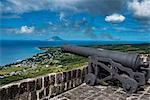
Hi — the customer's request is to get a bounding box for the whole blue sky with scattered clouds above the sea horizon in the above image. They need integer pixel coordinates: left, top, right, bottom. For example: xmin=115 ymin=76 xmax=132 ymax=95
xmin=0 ymin=0 xmax=150 ymax=42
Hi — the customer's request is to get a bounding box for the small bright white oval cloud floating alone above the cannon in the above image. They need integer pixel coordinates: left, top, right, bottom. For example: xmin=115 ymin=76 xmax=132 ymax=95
xmin=105 ymin=14 xmax=125 ymax=23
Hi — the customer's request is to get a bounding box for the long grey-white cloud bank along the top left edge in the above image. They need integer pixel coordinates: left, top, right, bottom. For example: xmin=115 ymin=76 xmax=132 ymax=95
xmin=0 ymin=0 xmax=80 ymax=13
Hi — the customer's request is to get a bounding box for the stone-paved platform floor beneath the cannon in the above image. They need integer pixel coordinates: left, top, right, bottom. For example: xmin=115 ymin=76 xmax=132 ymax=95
xmin=50 ymin=83 xmax=150 ymax=100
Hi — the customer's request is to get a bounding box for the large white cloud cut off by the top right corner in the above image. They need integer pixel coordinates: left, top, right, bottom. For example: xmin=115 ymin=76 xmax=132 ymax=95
xmin=128 ymin=0 xmax=150 ymax=18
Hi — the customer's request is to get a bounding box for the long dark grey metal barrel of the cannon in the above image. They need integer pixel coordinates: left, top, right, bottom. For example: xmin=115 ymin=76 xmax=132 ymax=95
xmin=61 ymin=45 xmax=142 ymax=70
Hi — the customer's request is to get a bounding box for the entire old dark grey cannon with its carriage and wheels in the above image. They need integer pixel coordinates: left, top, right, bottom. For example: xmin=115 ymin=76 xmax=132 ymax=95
xmin=61 ymin=45 xmax=150 ymax=93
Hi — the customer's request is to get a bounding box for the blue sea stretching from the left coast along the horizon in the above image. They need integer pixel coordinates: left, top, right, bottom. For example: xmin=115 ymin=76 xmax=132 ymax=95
xmin=0 ymin=40 xmax=149 ymax=66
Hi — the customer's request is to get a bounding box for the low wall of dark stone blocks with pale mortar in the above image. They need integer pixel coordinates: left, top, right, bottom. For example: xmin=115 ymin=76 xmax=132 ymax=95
xmin=0 ymin=67 xmax=87 ymax=100
